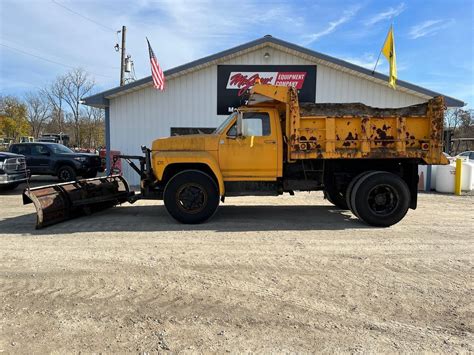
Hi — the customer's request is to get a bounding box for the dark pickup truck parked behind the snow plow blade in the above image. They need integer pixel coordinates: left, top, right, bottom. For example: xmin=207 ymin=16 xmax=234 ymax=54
xmin=10 ymin=142 xmax=104 ymax=181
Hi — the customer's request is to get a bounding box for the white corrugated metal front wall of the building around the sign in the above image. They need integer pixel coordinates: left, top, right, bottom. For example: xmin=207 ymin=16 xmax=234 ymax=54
xmin=110 ymin=47 xmax=426 ymax=185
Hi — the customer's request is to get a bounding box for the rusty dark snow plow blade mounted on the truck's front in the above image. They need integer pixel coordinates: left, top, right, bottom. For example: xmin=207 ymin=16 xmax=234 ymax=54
xmin=23 ymin=175 xmax=134 ymax=229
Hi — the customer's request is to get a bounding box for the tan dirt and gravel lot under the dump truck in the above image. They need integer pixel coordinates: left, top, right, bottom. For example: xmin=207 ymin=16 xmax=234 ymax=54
xmin=0 ymin=179 xmax=474 ymax=353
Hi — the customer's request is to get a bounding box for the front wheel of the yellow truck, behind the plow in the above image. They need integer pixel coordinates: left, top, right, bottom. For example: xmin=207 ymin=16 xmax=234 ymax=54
xmin=163 ymin=170 xmax=219 ymax=224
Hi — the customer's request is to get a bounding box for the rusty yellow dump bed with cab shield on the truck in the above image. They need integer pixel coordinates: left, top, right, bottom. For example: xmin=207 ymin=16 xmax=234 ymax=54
xmin=249 ymin=85 xmax=448 ymax=164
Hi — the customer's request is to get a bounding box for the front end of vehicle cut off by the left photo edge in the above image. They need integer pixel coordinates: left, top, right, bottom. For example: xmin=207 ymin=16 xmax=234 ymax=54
xmin=0 ymin=152 xmax=28 ymax=190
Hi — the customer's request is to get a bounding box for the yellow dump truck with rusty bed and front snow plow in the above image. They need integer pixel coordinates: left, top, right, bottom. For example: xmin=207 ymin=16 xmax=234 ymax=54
xmin=24 ymin=84 xmax=448 ymax=227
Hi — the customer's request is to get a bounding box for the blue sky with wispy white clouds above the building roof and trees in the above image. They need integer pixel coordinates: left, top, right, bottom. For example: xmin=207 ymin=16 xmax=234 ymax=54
xmin=0 ymin=0 xmax=474 ymax=108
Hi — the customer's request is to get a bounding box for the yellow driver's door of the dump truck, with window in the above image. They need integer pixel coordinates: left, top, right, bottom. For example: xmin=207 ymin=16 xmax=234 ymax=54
xmin=219 ymin=111 xmax=278 ymax=181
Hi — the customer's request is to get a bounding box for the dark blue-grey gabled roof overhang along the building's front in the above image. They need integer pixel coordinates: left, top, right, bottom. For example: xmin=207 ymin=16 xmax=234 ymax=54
xmin=83 ymin=35 xmax=465 ymax=108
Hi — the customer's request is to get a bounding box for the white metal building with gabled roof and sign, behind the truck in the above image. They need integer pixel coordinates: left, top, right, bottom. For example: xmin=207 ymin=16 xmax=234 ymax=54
xmin=84 ymin=35 xmax=464 ymax=184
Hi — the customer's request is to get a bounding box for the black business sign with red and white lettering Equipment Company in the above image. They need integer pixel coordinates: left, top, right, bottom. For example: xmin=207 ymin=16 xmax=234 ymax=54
xmin=217 ymin=65 xmax=316 ymax=115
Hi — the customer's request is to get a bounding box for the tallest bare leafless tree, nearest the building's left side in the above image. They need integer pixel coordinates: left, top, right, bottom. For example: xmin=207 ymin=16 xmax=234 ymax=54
xmin=64 ymin=68 xmax=94 ymax=146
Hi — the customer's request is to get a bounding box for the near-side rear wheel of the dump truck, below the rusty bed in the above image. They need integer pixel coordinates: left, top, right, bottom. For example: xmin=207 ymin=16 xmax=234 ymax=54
xmin=351 ymin=171 xmax=410 ymax=227
